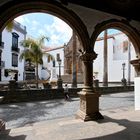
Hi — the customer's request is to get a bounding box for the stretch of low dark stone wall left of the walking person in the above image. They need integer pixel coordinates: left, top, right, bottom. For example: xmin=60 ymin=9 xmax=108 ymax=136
xmin=0 ymin=89 xmax=64 ymax=103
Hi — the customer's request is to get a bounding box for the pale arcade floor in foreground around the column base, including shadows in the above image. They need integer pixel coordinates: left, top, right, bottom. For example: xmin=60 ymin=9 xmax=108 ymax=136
xmin=0 ymin=104 xmax=140 ymax=140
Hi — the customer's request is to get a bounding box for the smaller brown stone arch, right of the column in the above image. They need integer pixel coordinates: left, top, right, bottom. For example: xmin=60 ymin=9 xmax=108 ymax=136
xmin=91 ymin=19 xmax=140 ymax=57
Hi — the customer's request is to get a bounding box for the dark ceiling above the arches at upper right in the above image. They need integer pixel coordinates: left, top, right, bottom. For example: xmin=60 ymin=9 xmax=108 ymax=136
xmin=60 ymin=0 xmax=140 ymax=21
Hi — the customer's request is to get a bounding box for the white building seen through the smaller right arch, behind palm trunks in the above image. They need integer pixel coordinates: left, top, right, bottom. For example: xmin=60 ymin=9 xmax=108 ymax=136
xmin=93 ymin=32 xmax=136 ymax=82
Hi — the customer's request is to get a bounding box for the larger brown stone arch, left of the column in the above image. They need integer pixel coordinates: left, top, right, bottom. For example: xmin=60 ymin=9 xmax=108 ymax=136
xmin=0 ymin=0 xmax=91 ymax=51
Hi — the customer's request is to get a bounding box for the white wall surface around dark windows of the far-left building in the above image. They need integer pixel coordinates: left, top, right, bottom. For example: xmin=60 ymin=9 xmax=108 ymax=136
xmin=2 ymin=26 xmax=25 ymax=81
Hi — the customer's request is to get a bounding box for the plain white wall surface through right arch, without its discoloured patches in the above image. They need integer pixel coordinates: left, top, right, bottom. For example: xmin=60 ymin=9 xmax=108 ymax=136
xmin=93 ymin=34 xmax=136 ymax=82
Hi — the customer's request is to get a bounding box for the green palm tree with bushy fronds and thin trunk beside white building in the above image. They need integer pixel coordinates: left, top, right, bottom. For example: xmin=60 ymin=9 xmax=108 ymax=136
xmin=19 ymin=36 xmax=54 ymax=88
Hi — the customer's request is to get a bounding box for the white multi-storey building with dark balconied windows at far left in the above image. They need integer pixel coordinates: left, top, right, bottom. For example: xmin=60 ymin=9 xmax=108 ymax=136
xmin=0 ymin=21 xmax=27 ymax=81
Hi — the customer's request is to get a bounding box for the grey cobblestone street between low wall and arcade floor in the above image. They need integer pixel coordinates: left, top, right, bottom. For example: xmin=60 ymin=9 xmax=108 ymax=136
xmin=0 ymin=92 xmax=134 ymax=129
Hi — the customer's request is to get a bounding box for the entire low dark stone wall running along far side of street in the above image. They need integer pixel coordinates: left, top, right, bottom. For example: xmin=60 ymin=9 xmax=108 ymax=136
xmin=0 ymin=86 xmax=134 ymax=104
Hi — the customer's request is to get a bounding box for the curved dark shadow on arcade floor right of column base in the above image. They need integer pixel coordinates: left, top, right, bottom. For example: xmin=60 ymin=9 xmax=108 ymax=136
xmin=80 ymin=116 xmax=140 ymax=140
